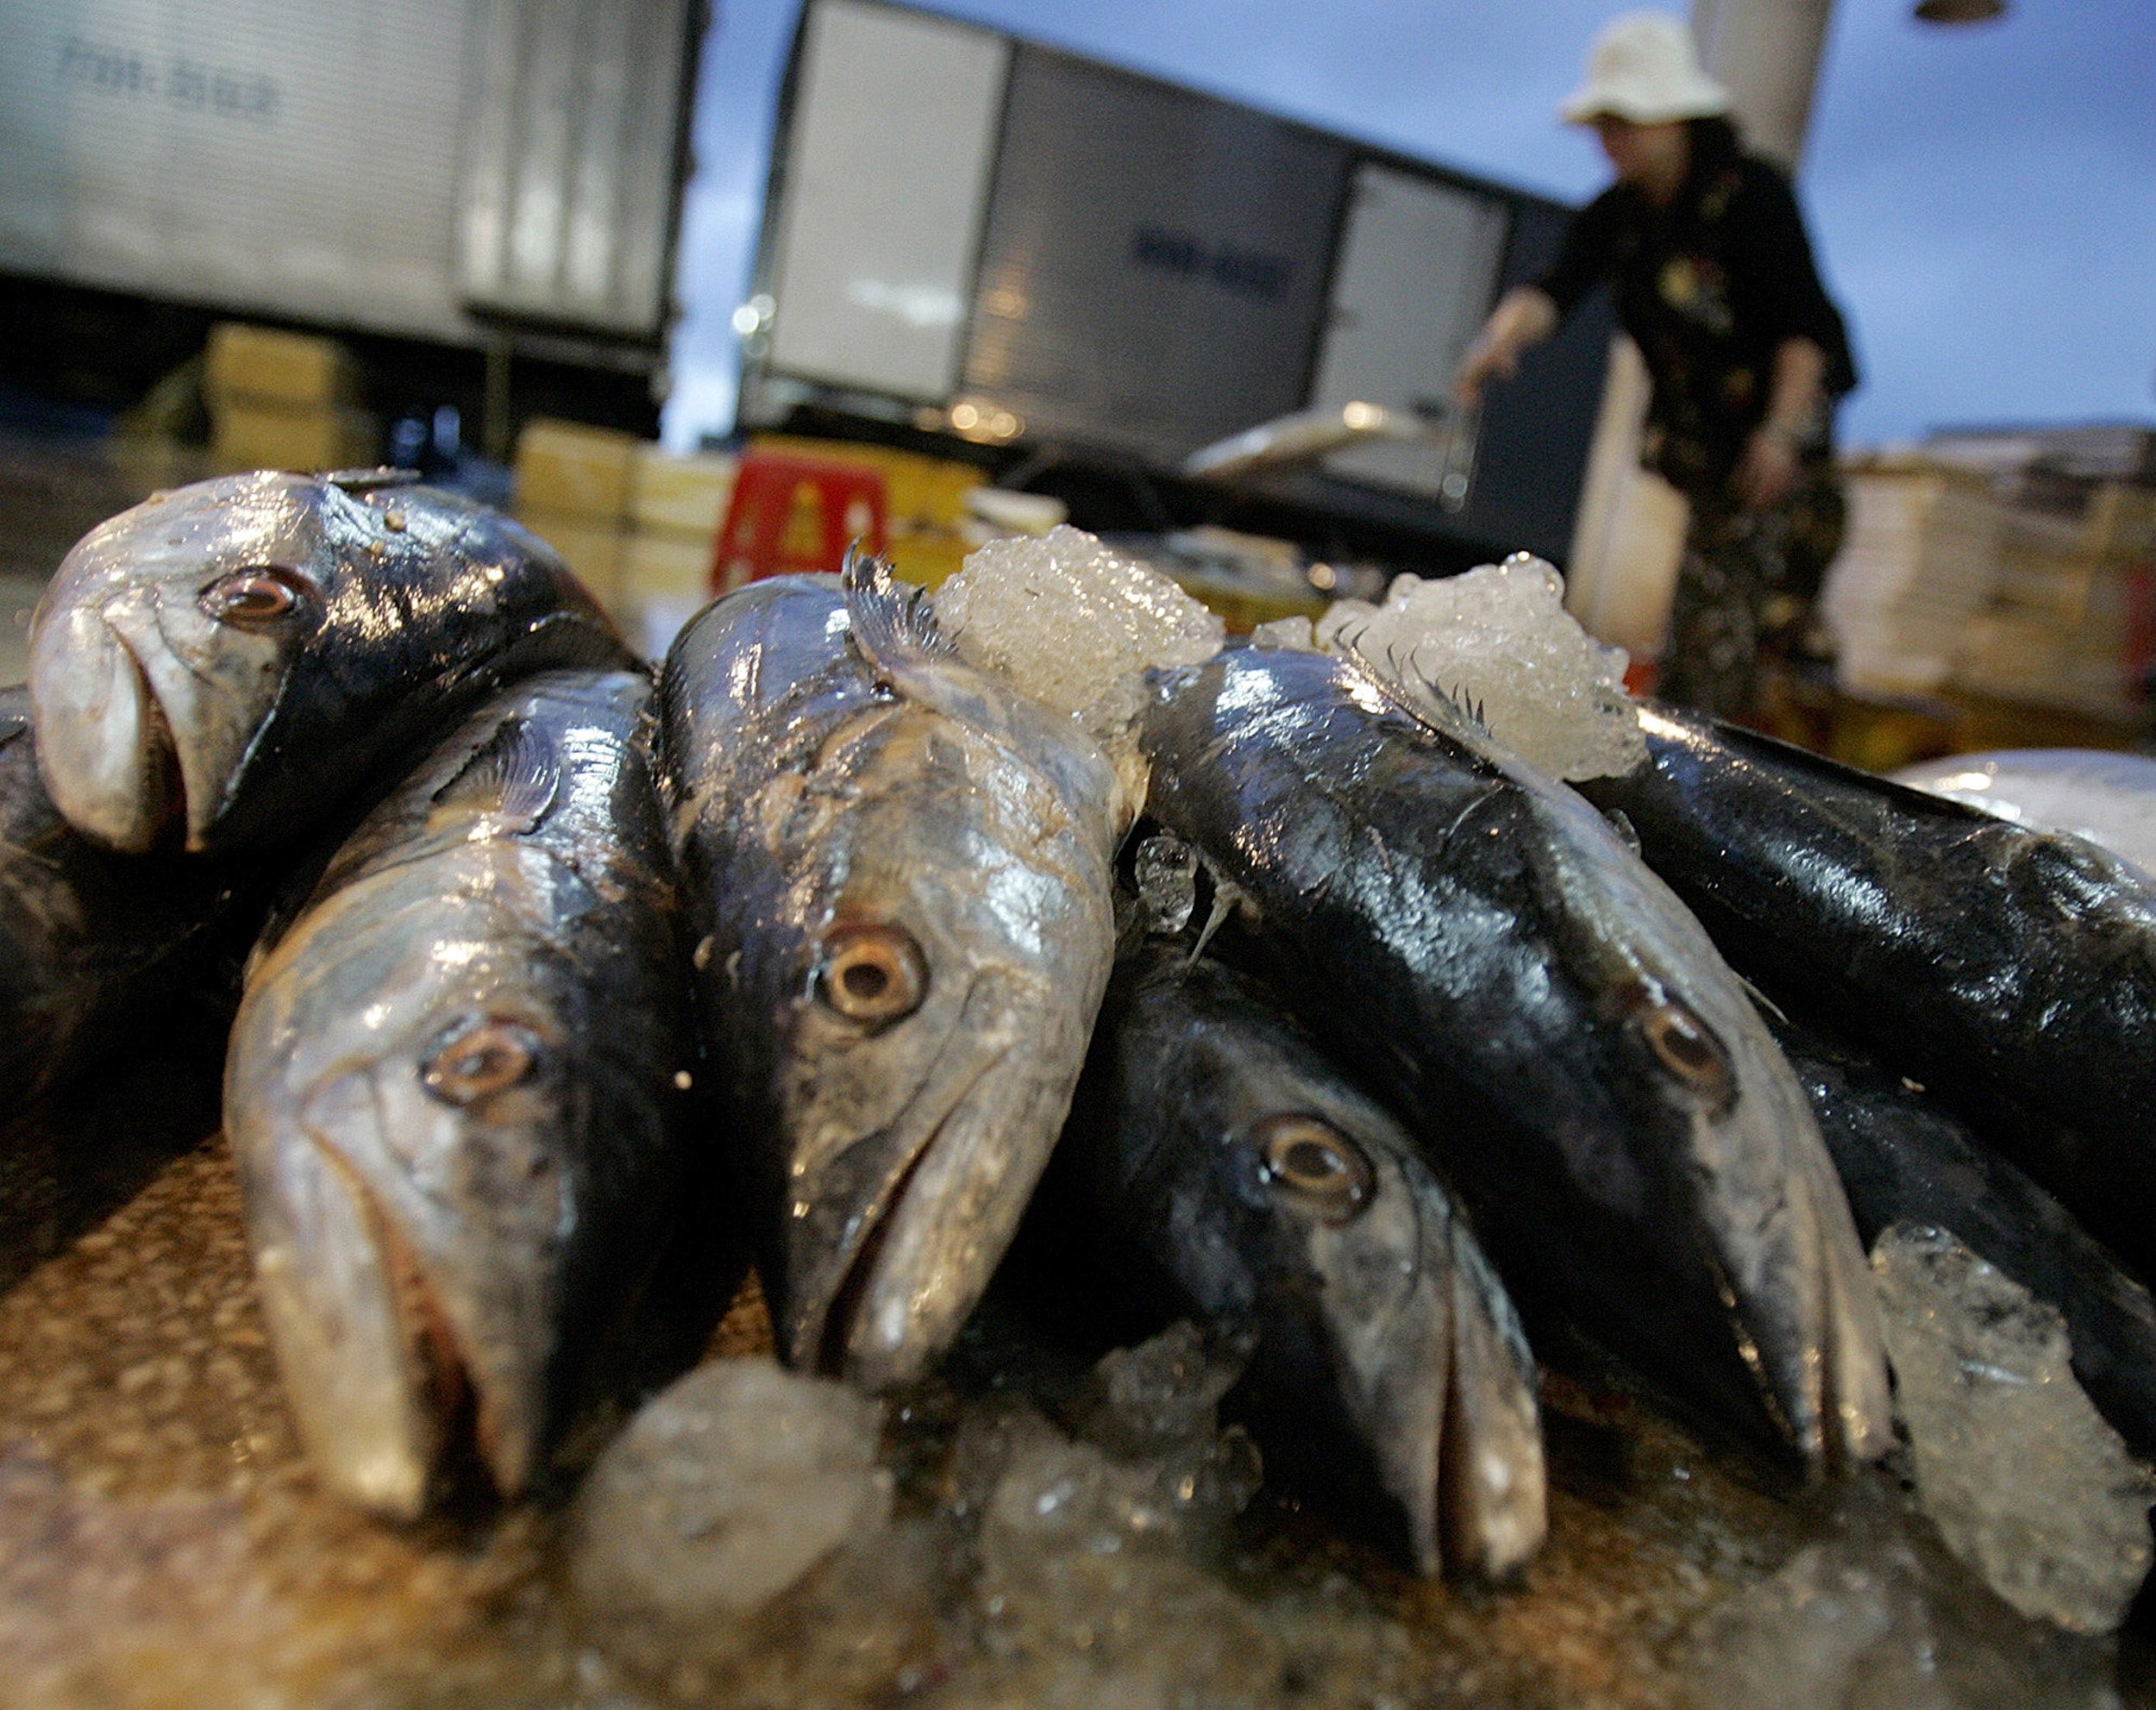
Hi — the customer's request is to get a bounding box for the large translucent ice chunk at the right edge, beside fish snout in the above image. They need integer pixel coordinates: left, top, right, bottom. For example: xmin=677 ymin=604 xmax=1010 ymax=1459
xmin=1871 ymin=1223 xmax=2156 ymax=1632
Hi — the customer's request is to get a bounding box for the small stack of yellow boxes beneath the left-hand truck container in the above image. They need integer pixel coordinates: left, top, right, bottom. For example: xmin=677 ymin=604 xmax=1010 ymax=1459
xmin=203 ymin=322 xmax=382 ymax=474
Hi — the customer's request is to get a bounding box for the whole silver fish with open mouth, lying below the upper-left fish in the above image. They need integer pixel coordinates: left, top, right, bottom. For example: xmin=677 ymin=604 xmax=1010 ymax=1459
xmin=224 ymin=671 xmax=694 ymax=1520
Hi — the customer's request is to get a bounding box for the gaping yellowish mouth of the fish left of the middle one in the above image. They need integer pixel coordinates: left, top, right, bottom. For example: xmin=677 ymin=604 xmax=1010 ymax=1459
xmin=257 ymin=1130 xmax=543 ymax=1520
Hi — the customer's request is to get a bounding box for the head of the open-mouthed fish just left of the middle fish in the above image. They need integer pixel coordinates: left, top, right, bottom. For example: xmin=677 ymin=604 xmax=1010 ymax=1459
xmin=227 ymin=914 xmax=599 ymax=1518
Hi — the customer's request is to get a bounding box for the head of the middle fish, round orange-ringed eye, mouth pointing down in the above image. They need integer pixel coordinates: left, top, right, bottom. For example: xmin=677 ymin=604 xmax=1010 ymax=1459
xmin=766 ymin=746 xmax=1115 ymax=1388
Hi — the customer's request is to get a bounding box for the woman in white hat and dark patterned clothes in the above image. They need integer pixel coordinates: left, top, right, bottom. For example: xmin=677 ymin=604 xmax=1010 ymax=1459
xmin=1456 ymin=13 xmax=1857 ymax=718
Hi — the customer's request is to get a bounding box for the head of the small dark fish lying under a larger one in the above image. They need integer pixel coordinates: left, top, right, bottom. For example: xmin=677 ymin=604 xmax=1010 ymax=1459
xmin=1207 ymin=1089 xmax=1546 ymax=1576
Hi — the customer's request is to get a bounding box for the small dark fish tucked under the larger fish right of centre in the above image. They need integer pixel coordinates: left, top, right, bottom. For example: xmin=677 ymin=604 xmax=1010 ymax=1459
xmin=1044 ymin=938 xmax=1548 ymax=1578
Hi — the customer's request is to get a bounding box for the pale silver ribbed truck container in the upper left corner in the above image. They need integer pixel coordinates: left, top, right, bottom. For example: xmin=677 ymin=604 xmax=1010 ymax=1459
xmin=0 ymin=0 xmax=703 ymax=354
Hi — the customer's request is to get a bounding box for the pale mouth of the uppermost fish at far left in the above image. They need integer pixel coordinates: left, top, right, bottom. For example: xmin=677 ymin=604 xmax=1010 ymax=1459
xmin=30 ymin=612 xmax=188 ymax=854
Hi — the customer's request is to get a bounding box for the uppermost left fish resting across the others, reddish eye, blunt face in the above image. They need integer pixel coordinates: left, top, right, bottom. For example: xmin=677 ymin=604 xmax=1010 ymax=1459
xmin=30 ymin=470 xmax=632 ymax=854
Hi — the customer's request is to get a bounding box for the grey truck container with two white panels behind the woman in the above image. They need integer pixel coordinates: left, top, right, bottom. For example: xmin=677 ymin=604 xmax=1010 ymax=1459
xmin=740 ymin=0 xmax=1611 ymax=561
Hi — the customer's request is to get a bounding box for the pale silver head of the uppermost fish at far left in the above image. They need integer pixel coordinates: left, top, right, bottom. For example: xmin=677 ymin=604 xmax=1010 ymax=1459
xmin=30 ymin=473 xmax=371 ymax=854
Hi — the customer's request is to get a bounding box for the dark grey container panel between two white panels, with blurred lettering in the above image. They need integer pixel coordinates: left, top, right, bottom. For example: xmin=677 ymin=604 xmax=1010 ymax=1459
xmin=966 ymin=46 xmax=1350 ymax=468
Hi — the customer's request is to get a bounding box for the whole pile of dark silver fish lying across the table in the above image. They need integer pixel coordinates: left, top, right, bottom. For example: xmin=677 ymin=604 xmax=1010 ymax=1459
xmin=0 ymin=470 xmax=2156 ymax=1604
